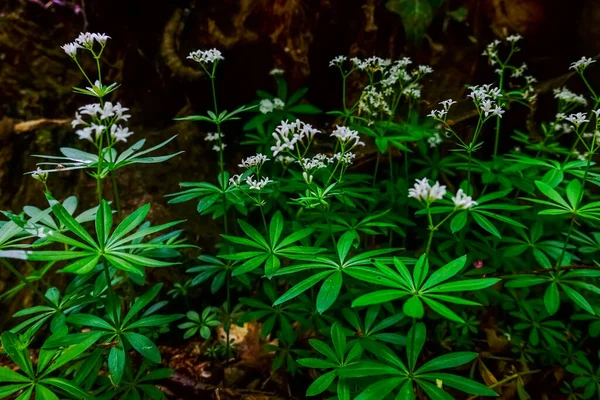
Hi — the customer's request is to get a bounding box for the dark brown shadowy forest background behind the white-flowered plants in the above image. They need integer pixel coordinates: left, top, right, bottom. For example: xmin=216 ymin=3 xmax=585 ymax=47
xmin=0 ymin=0 xmax=600 ymax=325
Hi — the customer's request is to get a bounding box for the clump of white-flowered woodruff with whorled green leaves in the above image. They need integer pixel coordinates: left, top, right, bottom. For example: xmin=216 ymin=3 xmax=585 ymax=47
xmin=0 ymin=34 xmax=600 ymax=400
